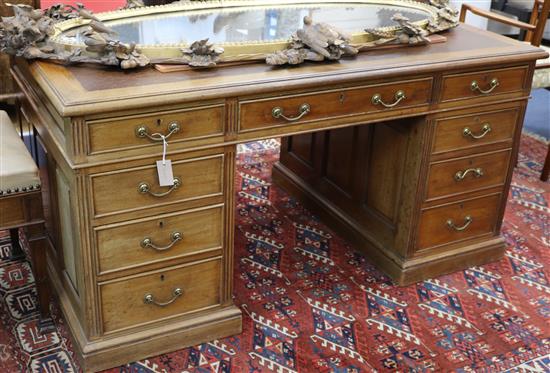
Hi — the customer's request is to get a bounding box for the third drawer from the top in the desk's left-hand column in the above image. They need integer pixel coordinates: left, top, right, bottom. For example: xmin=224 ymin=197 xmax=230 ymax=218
xmin=95 ymin=205 xmax=224 ymax=274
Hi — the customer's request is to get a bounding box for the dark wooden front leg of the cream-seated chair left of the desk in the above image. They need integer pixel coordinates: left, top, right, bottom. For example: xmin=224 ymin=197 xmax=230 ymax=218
xmin=27 ymin=224 xmax=55 ymax=333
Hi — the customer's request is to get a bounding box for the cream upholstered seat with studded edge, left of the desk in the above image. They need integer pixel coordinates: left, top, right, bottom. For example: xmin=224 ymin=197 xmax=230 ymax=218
xmin=0 ymin=111 xmax=40 ymax=195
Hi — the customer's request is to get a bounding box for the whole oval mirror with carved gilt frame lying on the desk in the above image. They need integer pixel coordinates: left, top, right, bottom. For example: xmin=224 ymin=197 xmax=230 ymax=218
xmin=0 ymin=0 xmax=458 ymax=69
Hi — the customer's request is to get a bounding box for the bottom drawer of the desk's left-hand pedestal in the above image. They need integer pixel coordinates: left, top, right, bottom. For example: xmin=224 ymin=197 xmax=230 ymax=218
xmin=100 ymin=258 xmax=222 ymax=332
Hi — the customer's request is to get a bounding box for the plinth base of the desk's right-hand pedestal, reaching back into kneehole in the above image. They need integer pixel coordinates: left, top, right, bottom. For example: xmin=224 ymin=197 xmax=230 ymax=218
xmin=273 ymin=163 xmax=505 ymax=285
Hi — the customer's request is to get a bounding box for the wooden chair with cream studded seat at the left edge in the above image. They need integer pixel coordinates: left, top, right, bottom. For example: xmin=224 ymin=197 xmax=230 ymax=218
xmin=0 ymin=111 xmax=54 ymax=333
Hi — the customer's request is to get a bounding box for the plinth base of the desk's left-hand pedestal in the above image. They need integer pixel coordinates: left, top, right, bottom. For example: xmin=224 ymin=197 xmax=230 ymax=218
xmin=49 ymin=256 xmax=242 ymax=372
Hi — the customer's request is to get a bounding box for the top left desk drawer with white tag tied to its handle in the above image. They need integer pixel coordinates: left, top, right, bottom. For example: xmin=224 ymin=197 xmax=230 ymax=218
xmin=87 ymin=105 xmax=224 ymax=154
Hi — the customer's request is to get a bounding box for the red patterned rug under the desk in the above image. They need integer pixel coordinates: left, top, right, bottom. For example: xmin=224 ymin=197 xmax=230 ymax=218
xmin=0 ymin=132 xmax=550 ymax=373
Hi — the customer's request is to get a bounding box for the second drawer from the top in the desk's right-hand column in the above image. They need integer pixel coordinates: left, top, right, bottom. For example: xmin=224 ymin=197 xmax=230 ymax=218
xmin=433 ymin=108 xmax=519 ymax=153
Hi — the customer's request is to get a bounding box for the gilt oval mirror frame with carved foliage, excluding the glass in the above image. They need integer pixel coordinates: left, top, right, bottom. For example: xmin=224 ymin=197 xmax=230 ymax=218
xmin=0 ymin=0 xmax=458 ymax=69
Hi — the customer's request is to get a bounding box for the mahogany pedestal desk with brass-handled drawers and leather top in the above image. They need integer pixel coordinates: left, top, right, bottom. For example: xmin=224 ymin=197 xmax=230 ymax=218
xmin=12 ymin=25 xmax=546 ymax=370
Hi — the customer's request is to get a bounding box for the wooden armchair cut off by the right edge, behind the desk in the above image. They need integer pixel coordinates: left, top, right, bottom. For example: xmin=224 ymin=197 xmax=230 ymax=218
xmin=460 ymin=0 xmax=550 ymax=181
